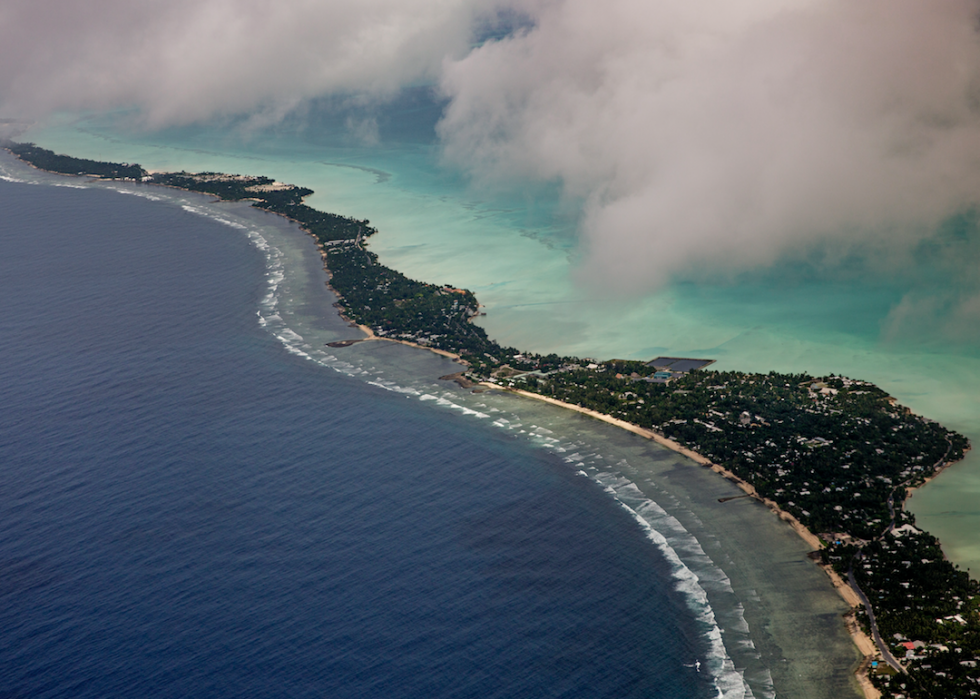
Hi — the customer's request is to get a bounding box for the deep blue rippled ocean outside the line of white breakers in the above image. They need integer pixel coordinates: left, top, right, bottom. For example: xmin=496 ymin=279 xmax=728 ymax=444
xmin=0 ymin=182 xmax=716 ymax=699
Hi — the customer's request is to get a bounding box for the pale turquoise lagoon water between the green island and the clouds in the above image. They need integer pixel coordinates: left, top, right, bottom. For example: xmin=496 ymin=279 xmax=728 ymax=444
xmin=21 ymin=104 xmax=980 ymax=570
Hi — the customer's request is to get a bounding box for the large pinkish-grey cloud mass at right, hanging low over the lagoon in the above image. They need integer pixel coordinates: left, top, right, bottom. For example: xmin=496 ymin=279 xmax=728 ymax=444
xmin=441 ymin=0 xmax=980 ymax=290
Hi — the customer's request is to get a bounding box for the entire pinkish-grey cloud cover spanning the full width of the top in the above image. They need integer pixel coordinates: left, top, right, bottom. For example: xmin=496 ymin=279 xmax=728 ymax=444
xmin=0 ymin=0 xmax=980 ymax=308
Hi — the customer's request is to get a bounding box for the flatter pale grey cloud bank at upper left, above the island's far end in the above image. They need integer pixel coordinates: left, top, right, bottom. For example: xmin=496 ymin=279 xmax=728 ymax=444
xmin=0 ymin=0 xmax=487 ymax=127
